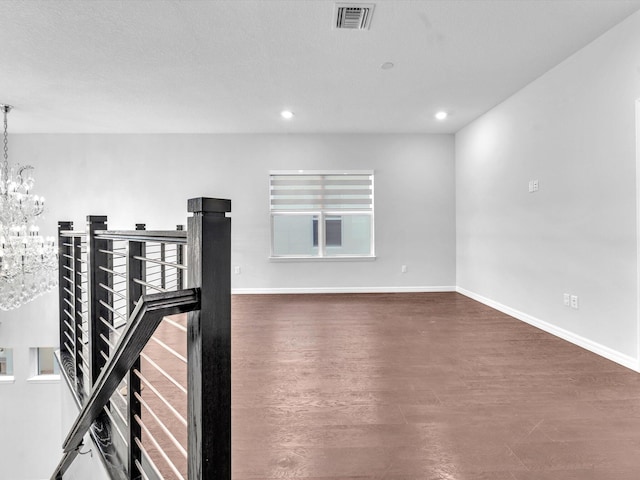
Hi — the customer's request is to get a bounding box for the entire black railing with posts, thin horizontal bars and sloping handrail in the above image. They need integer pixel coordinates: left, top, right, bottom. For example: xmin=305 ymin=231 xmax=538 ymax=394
xmin=52 ymin=199 xmax=230 ymax=480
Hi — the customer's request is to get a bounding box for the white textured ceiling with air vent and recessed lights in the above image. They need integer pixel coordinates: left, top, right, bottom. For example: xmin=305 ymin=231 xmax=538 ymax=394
xmin=0 ymin=0 xmax=640 ymax=133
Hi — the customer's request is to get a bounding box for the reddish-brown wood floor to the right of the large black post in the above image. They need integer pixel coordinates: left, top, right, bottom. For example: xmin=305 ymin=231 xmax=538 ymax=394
xmin=233 ymin=293 xmax=640 ymax=480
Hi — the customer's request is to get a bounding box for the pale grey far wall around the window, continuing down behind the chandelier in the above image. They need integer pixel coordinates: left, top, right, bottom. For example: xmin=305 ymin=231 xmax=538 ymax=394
xmin=0 ymin=134 xmax=455 ymax=480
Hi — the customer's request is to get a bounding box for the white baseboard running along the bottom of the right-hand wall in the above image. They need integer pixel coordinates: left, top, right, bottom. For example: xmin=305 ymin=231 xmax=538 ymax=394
xmin=456 ymin=287 xmax=640 ymax=372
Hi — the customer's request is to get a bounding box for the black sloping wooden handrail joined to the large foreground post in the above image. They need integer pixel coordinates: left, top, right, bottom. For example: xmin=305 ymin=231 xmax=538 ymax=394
xmin=51 ymin=288 xmax=200 ymax=480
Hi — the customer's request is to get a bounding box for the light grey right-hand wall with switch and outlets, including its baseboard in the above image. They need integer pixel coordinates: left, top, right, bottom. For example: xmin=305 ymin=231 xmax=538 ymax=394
xmin=456 ymin=14 xmax=640 ymax=368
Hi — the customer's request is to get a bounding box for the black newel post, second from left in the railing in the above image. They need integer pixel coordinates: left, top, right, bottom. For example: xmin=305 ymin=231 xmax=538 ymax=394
xmin=86 ymin=215 xmax=113 ymax=386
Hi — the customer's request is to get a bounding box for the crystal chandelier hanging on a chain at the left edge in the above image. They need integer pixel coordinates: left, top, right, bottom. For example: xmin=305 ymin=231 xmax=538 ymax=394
xmin=0 ymin=105 xmax=58 ymax=310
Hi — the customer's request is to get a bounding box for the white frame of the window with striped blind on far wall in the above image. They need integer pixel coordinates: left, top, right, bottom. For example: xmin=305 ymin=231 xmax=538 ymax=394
xmin=269 ymin=170 xmax=376 ymax=262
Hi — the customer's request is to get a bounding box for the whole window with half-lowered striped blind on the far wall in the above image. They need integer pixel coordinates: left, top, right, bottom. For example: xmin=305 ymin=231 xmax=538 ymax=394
xmin=270 ymin=171 xmax=374 ymax=258
